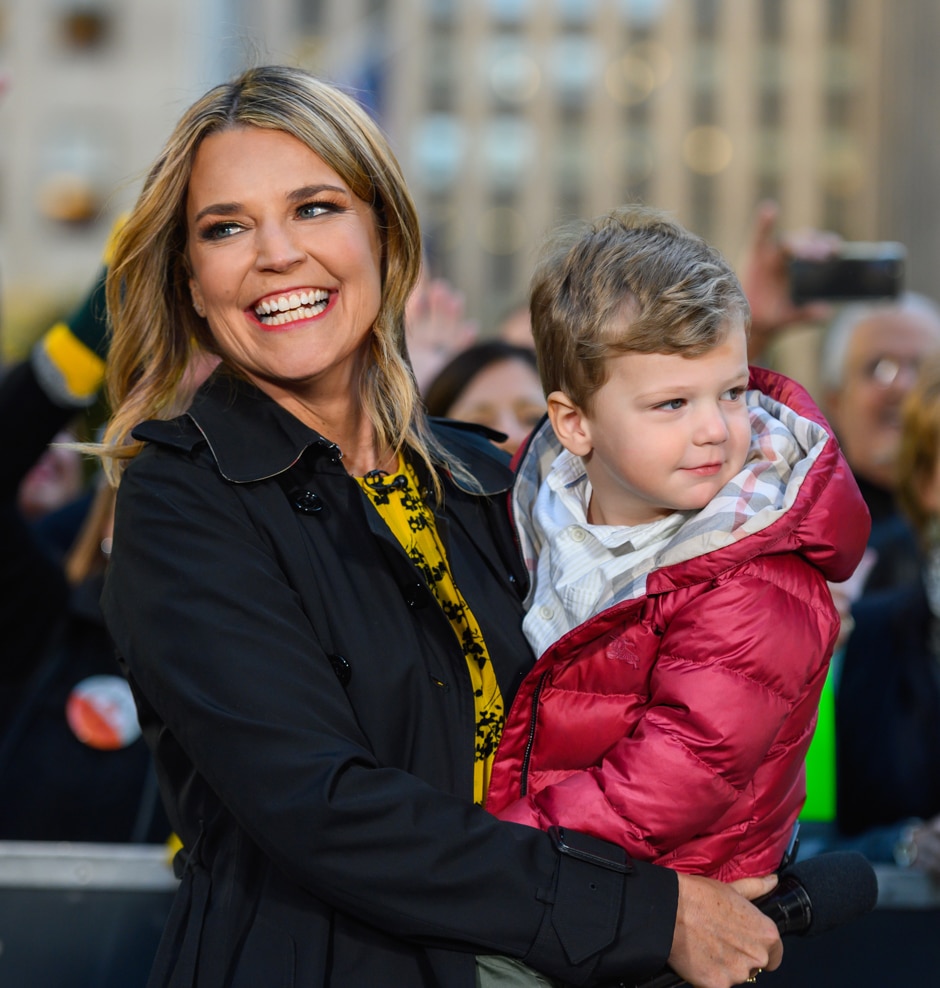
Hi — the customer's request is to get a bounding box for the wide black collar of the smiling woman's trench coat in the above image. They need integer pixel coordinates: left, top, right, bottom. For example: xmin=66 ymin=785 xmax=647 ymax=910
xmin=134 ymin=370 xmax=512 ymax=495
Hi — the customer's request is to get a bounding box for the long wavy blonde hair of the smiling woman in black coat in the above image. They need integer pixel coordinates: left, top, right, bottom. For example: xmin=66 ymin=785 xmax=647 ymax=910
xmin=98 ymin=66 xmax=460 ymax=485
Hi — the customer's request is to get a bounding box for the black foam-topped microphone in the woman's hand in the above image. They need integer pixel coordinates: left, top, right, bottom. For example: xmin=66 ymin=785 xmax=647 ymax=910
xmin=632 ymin=851 xmax=878 ymax=988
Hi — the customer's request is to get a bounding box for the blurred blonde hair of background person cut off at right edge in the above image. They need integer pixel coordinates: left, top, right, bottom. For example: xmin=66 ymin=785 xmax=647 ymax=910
xmin=896 ymin=356 xmax=940 ymax=546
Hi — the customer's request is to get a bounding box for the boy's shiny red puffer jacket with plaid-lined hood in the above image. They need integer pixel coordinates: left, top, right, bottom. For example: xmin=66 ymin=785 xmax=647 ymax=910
xmin=487 ymin=369 xmax=870 ymax=881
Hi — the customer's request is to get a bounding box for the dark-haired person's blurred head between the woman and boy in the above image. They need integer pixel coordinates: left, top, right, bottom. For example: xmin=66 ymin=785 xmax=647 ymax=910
xmin=424 ymin=340 xmax=545 ymax=453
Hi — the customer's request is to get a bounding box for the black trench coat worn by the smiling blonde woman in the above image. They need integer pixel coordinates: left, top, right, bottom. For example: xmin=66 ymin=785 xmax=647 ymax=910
xmin=103 ymin=374 xmax=677 ymax=988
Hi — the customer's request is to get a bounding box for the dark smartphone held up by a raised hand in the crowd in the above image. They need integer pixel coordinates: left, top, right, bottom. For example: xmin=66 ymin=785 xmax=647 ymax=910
xmin=789 ymin=240 xmax=907 ymax=305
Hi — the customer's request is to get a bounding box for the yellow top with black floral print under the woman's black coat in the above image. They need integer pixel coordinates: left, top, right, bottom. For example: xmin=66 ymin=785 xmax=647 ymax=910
xmin=357 ymin=456 xmax=505 ymax=803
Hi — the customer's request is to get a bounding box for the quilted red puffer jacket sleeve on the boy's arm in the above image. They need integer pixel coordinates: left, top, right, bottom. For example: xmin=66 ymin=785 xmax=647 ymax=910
xmin=499 ymin=557 xmax=837 ymax=871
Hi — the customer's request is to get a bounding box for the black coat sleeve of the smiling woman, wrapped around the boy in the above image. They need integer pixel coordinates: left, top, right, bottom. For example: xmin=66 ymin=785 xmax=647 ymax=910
xmin=103 ymin=448 xmax=677 ymax=984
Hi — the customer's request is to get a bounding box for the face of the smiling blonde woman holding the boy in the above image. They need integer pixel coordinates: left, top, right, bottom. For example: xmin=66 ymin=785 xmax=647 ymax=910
xmin=186 ymin=127 xmax=382 ymax=400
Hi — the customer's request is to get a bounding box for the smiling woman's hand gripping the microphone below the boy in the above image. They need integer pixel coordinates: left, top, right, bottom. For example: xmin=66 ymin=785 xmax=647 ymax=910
xmin=668 ymin=874 xmax=783 ymax=988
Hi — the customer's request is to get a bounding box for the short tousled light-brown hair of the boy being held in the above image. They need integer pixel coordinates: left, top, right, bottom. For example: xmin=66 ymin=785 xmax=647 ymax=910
xmin=530 ymin=205 xmax=750 ymax=410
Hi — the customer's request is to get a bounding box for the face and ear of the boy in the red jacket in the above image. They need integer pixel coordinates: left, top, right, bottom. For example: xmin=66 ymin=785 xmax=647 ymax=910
xmin=549 ymin=320 xmax=751 ymax=525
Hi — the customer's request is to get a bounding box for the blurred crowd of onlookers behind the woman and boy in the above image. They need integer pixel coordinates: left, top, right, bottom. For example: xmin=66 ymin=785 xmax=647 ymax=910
xmin=0 ymin=187 xmax=940 ymax=888
